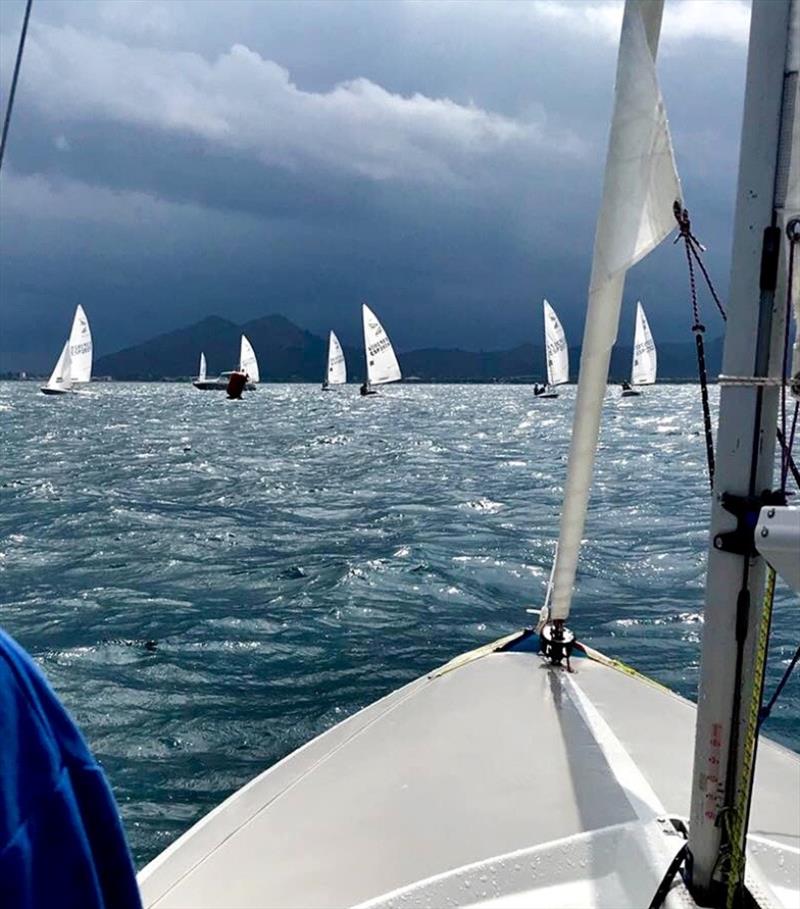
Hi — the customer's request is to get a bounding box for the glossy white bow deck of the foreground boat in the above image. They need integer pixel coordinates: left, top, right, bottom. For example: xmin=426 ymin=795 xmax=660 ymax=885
xmin=139 ymin=651 xmax=800 ymax=909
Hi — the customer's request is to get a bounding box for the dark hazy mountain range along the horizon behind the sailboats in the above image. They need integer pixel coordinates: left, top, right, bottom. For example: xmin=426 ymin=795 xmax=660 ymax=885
xmin=94 ymin=315 xmax=722 ymax=382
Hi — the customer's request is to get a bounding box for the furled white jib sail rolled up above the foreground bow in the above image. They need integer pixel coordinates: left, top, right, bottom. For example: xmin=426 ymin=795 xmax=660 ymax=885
xmin=551 ymin=0 xmax=680 ymax=619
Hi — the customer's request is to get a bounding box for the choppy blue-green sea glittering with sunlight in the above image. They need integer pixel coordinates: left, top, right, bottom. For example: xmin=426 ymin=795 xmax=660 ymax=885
xmin=0 ymin=383 xmax=800 ymax=865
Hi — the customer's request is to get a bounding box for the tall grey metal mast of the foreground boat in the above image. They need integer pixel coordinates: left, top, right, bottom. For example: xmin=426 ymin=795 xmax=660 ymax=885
xmin=689 ymin=0 xmax=800 ymax=901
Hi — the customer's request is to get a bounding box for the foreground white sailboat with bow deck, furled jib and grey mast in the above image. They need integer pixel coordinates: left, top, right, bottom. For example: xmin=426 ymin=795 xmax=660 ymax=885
xmin=139 ymin=0 xmax=800 ymax=909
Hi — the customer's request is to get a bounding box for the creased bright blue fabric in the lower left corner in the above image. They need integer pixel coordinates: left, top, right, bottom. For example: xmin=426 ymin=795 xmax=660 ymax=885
xmin=0 ymin=630 xmax=141 ymax=909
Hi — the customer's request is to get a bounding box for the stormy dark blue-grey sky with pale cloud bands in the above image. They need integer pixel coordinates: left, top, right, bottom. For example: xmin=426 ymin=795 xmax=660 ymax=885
xmin=0 ymin=0 xmax=749 ymax=369
